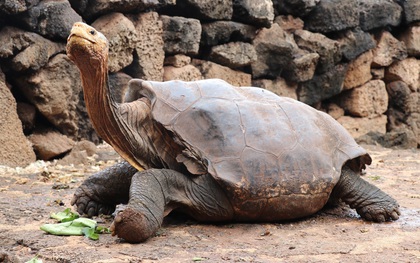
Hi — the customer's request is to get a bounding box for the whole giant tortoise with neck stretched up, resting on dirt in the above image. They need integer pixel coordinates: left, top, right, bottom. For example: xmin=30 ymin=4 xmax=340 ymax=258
xmin=67 ymin=22 xmax=400 ymax=242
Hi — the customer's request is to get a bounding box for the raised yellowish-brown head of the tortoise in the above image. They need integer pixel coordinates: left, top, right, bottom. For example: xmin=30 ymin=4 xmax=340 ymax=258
xmin=66 ymin=22 xmax=109 ymax=71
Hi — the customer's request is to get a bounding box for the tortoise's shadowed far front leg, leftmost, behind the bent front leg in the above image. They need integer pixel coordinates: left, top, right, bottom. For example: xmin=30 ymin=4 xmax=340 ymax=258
xmin=71 ymin=162 xmax=138 ymax=217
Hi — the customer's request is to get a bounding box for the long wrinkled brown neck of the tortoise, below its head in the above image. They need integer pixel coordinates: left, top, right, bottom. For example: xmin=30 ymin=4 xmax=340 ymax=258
xmin=80 ymin=55 xmax=182 ymax=169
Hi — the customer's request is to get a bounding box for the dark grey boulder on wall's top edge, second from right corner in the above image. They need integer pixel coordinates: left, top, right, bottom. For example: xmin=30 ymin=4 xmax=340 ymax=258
xmin=358 ymin=0 xmax=402 ymax=31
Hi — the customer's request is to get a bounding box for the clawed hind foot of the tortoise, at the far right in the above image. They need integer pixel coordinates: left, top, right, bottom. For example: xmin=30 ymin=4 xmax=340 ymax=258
xmin=356 ymin=201 xmax=401 ymax=223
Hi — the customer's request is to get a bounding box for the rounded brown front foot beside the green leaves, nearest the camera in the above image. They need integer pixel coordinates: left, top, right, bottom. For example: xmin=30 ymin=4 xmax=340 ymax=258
xmin=110 ymin=207 xmax=157 ymax=243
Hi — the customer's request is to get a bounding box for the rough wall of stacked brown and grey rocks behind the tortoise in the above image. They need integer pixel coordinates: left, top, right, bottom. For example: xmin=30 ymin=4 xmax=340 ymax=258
xmin=0 ymin=0 xmax=420 ymax=165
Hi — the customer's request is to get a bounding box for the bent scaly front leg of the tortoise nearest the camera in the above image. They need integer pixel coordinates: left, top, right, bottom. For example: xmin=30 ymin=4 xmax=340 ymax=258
xmin=111 ymin=169 xmax=233 ymax=243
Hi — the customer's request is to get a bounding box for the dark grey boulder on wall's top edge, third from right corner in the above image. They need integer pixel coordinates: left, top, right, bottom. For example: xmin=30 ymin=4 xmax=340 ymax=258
xmin=303 ymin=0 xmax=359 ymax=33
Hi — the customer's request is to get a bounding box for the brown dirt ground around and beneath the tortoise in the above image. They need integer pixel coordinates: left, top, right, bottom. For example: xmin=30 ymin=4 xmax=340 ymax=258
xmin=0 ymin=146 xmax=420 ymax=263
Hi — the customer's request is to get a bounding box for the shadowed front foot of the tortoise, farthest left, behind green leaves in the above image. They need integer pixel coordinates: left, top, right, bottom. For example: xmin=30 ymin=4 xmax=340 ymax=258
xmin=71 ymin=188 xmax=115 ymax=217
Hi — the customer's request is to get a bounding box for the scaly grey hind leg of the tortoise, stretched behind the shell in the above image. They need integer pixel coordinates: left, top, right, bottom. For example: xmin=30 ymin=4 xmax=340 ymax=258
xmin=332 ymin=166 xmax=401 ymax=222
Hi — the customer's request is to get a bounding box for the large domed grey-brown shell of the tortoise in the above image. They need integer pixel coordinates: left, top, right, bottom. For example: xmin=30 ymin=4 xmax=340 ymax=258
xmin=130 ymin=79 xmax=371 ymax=220
